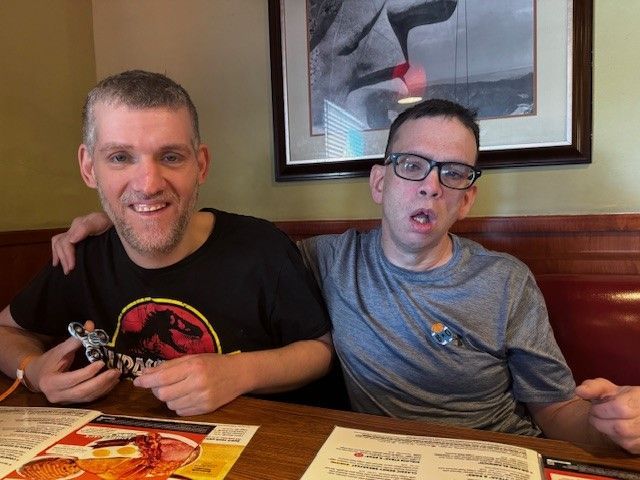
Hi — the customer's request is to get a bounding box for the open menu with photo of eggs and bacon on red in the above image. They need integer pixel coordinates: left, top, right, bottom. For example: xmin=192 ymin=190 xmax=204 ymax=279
xmin=0 ymin=407 xmax=258 ymax=480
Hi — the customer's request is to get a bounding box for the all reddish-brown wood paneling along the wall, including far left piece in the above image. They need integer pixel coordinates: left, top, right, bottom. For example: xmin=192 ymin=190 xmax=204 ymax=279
xmin=0 ymin=214 xmax=640 ymax=308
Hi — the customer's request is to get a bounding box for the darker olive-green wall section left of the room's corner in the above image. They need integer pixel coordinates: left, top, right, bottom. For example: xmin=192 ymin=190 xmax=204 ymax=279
xmin=0 ymin=0 xmax=98 ymax=231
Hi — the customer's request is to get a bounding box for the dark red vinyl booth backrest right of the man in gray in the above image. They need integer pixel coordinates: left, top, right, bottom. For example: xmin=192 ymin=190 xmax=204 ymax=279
xmin=536 ymin=273 xmax=640 ymax=385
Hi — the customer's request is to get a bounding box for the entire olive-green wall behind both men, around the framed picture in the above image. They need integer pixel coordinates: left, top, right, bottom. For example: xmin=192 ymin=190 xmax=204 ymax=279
xmin=0 ymin=0 xmax=640 ymax=230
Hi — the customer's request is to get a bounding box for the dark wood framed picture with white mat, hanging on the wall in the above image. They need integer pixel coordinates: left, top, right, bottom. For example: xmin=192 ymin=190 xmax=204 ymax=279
xmin=269 ymin=0 xmax=593 ymax=181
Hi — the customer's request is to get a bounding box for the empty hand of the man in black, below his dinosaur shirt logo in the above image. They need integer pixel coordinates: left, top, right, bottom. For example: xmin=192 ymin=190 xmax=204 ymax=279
xmin=133 ymin=353 xmax=249 ymax=415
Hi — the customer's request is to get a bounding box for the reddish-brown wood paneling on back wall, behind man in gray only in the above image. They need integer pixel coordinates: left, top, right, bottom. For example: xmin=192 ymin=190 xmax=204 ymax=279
xmin=276 ymin=214 xmax=640 ymax=274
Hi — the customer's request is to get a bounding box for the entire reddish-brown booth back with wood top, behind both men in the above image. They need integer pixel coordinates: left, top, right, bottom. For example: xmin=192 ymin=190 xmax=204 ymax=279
xmin=0 ymin=226 xmax=640 ymax=408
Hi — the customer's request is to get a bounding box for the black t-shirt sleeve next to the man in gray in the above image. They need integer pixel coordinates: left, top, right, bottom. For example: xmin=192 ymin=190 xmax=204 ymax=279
xmin=272 ymin=233 xmax=330 ymax=344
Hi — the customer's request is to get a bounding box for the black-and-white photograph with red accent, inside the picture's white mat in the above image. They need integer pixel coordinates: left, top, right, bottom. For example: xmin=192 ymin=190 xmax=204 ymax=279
xmin=307 ymin=0 xmax=535 ymax=139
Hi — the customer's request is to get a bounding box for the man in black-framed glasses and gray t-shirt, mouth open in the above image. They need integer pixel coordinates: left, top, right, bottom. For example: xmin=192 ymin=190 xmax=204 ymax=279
xmin=299 ymin=100 xmax=640 ymax=453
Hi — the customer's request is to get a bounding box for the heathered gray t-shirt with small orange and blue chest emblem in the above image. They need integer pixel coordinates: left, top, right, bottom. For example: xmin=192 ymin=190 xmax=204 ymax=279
xmin=300 ymin=229 xmax=575 ymax=435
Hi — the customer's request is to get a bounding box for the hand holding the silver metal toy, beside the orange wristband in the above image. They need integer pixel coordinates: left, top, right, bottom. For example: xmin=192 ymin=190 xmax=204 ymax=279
xmin=25 ymin=322 xmax=120 ymax=403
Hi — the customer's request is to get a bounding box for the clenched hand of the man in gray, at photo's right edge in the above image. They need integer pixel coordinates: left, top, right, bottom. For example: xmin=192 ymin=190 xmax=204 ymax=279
xmin=576 ymin=378 xmax=640 ymax=454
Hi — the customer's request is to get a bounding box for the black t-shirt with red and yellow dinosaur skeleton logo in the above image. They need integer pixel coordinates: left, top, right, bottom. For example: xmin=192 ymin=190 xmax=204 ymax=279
xmin=10 ymin=209 xmax=329 ymax=376
